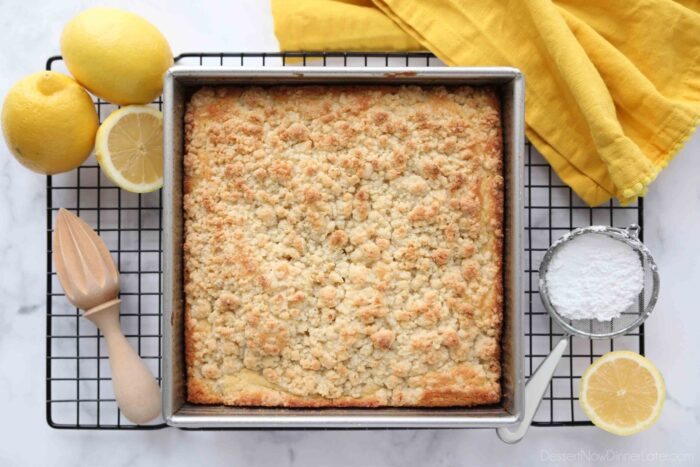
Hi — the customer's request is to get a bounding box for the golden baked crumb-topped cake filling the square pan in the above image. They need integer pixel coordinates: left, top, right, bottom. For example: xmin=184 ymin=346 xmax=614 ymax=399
xmin=184 ymin=86 xmax=503 ymax=407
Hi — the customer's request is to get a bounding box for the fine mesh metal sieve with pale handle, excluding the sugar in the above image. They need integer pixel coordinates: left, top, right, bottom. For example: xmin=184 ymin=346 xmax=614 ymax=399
xmin=497 ymin=224 xmax=659 ymax=443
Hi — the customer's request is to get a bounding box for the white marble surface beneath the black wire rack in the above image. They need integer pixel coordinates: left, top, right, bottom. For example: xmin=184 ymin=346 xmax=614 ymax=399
xmin=0 ymin=0 xmax=700 ymax=467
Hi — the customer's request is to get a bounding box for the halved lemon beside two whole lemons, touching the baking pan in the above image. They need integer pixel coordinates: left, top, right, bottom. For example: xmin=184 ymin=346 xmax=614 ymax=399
xmin=95 ymin=105 xmax=163 ymax=193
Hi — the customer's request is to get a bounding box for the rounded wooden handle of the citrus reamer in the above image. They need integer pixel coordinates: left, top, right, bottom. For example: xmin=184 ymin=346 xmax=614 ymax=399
xmin=85 ymin=300 xmax=161 ymax=424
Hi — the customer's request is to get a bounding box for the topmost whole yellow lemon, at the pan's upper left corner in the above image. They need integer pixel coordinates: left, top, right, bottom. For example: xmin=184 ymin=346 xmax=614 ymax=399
xmin=61 ymin=7 xmax=173 ymax=105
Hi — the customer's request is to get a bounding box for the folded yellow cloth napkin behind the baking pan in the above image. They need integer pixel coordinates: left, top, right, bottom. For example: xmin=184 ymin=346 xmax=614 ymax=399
xmin=272 ymin=0 xmax=700 ymax=205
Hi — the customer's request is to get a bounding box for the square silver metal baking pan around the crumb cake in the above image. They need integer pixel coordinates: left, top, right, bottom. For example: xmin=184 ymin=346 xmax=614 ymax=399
xmin=162 ymin=66 xmax=524 ymax=429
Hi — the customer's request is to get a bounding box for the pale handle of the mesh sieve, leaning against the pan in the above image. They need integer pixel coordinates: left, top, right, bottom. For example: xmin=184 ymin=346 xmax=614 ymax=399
xmin=496 ymin=335 xmax=569 ymax=444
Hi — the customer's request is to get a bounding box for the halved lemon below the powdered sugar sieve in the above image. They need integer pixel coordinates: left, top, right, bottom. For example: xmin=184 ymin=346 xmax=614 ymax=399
xmin=579 ymin=350 xmax=666 ymax=436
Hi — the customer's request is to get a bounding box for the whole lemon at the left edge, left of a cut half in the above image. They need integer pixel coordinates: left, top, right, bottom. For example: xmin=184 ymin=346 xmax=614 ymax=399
xmin=2 ymin=71 xmax=99 ymax=175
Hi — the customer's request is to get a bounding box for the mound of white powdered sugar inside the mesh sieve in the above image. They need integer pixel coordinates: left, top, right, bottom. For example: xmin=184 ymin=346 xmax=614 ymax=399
xmin=545 ymin=233 xmax=644 ymax=321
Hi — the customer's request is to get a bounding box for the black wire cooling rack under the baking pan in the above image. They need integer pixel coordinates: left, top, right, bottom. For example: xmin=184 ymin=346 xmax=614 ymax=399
xmin=46 ymin=53 xmax=644 ymax=429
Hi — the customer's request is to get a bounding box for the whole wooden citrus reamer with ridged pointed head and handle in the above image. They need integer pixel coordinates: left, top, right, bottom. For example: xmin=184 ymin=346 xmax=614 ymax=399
xmin=53 ymin=208 xmax=161 ymax=423
